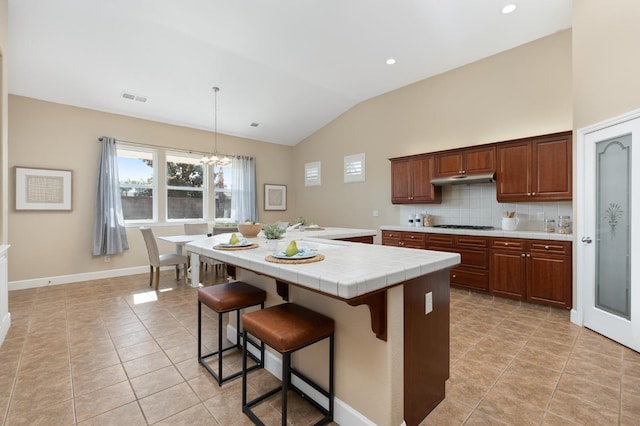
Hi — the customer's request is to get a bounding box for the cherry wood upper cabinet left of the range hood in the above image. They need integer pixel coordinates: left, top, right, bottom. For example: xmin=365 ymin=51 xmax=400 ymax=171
xmin=390 ymin=155 xmax=442 ymax=204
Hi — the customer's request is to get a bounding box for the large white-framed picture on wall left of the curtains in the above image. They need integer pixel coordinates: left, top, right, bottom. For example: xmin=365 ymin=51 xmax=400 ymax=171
xmin=16 ymin=167 xmax=73 ymax=211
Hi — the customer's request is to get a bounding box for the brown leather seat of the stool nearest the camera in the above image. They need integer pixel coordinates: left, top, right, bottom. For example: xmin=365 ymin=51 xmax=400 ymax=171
xmin=242 ymin=303 xmax=334 ymax=353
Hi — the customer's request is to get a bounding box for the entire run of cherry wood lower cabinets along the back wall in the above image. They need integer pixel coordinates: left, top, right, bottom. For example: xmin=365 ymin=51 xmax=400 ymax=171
xmin=382 ymin=231 xmax=572 ymax=309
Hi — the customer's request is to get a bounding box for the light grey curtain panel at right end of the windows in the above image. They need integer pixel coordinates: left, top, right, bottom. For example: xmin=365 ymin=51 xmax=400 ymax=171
xmin=231 ymin=156 xmax=258 ymax=223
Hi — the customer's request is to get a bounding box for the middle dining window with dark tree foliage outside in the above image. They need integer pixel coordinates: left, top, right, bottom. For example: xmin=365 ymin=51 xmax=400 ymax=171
xmin=166 ymin=152 xmax=206 ymax=220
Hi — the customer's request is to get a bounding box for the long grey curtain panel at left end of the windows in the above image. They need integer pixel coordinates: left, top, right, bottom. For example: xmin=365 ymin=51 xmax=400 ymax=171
xmin=92 ymin=136 xmax=129 ymax=256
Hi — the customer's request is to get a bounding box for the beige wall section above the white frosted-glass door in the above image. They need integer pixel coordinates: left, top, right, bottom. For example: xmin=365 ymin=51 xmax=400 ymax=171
xmin=573 ymin=0 xmax=640 ymax=130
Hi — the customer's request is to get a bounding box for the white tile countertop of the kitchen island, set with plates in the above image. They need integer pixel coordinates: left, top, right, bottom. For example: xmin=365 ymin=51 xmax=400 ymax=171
xmin=187 ymin=228 xmax=460 ymax=299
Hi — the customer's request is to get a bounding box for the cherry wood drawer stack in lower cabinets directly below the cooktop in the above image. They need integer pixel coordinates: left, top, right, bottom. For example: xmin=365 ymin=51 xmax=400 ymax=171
xmin=427 ymin=234 xmax=489 ymax=292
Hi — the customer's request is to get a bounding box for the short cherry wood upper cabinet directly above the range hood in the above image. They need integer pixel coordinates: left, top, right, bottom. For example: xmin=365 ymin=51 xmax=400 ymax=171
xmin=434 ymin=145 xmax=496 ymax=177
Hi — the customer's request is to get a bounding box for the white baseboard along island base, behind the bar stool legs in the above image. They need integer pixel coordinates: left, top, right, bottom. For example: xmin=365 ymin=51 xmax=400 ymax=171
xmin=227 ymin=324 xmax=376 ymax=426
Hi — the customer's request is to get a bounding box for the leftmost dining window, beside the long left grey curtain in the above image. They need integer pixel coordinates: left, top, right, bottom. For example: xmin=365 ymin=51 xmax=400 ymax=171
xmin=117 ymin=146 xmax=157 ymax=222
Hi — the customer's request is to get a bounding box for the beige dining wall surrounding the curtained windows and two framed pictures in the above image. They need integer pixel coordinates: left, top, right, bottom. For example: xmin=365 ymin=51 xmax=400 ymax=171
xmin=8 ymin=95 xmax=294 ymax=284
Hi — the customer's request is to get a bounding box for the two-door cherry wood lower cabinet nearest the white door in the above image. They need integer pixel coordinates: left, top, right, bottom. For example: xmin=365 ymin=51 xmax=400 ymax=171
xmin=489 ymin=238 xmax=572 ymax=309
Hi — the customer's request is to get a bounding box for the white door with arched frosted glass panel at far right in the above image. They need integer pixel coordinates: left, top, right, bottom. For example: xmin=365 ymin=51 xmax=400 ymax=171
xmin=576 ymin=111 xmax=640 ymax=351
